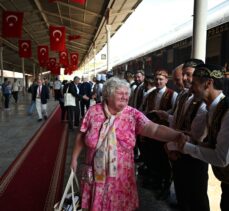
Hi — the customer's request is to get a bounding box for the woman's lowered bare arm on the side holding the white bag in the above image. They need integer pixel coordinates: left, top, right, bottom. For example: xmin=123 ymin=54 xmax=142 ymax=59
xmin=71 ymin=132 xmax=85 ymax=172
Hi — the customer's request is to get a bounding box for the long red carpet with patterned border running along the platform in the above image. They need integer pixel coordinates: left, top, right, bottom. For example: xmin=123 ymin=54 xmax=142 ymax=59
xmin=0 ymin=107 xmax=68 ymax=211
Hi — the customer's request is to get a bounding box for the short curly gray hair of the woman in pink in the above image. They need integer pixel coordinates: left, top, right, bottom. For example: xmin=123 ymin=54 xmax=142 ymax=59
xmin=102 ymin=77 xmax=130 ymax=101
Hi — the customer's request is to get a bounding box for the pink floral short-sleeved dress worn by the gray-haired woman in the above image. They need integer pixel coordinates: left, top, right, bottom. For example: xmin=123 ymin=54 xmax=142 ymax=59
xmin=80 ymin=104 xmax=149 ymax=211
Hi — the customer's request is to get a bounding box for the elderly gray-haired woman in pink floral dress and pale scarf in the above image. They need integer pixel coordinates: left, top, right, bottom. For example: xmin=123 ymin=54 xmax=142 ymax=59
xmin=71 ymin=77 xmax=184 ymax=211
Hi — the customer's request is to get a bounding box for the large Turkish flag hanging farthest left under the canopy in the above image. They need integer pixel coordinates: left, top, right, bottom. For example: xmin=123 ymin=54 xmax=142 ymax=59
xmin=2 ymin=11 xmax=23 ymax=38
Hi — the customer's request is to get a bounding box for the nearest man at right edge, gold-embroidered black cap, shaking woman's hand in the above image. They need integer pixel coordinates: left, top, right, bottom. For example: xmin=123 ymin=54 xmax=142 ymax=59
xmin=174 ymin=64 xmax=229 ymax=211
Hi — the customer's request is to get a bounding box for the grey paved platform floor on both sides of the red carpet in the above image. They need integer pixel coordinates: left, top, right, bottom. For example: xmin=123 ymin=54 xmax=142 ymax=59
xmin=0 ymin=94 xmax=220 ymax=211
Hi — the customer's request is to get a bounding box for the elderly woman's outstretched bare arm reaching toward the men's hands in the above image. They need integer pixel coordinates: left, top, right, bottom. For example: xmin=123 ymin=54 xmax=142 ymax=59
xmin=140 ymin=122 xmax=186 ymax=142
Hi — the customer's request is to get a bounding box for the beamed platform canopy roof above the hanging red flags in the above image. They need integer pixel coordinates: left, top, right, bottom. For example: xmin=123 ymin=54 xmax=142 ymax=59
xmin=0 ymin=0 xmax=142 ymax=74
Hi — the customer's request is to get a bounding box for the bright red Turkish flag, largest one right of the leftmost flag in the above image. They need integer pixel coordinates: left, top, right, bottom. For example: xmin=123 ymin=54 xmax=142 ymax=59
xmin=49 ymin=26 xmax=65 ymax=51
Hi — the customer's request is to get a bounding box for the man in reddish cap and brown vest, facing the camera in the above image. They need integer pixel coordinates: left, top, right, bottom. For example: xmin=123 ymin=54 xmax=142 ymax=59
xmin=142 ymin=68 xmax=177 ymax=200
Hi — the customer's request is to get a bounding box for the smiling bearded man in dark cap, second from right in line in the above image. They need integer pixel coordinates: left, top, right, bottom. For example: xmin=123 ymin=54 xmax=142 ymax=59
xmin=157 ymin=59 xmax=210 ymax=211
